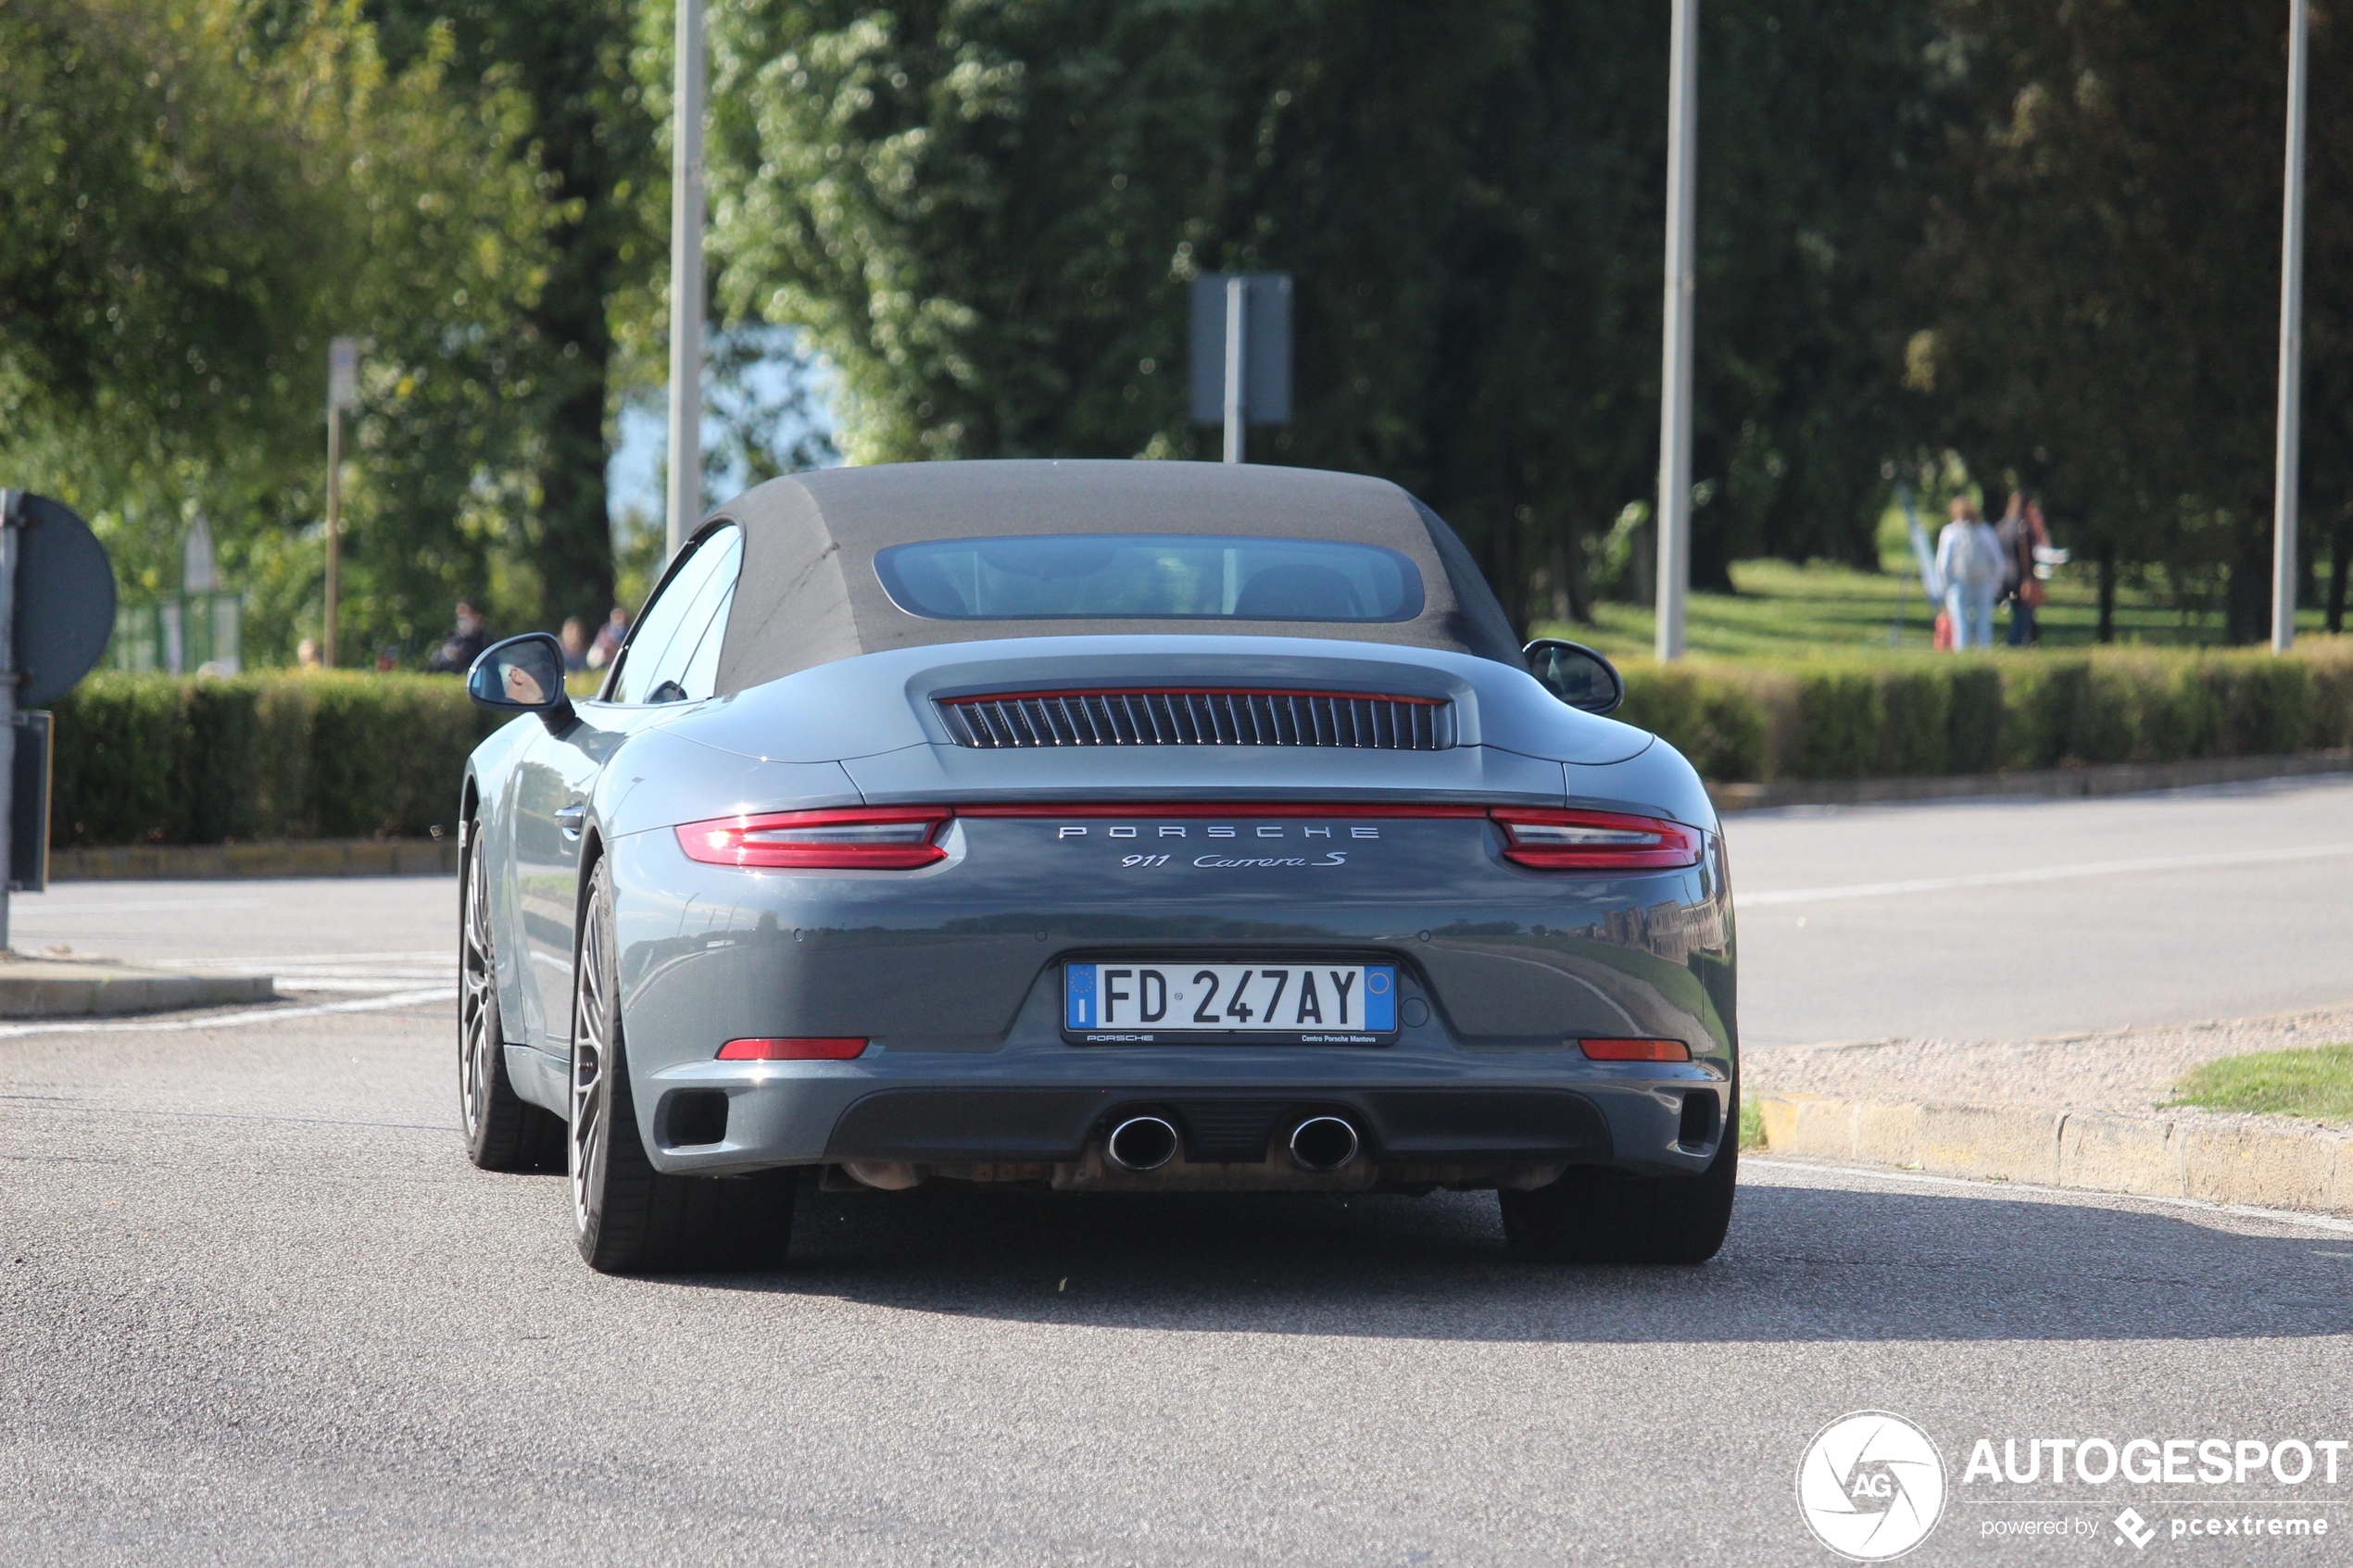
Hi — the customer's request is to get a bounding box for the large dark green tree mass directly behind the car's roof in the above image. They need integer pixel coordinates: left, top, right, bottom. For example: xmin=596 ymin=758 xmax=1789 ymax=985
xmin=713 ymin=0 xmax=1927 ymax=621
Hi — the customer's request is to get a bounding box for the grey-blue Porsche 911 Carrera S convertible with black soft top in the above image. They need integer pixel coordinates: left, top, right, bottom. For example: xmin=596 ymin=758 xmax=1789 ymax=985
xmin=459 ymin=460 xmax=1739 ymax=1272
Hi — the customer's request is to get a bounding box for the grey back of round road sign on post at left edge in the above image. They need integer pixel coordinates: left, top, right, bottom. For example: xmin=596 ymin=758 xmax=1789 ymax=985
xmin=0 ymin=489 xmax=115 ymax=952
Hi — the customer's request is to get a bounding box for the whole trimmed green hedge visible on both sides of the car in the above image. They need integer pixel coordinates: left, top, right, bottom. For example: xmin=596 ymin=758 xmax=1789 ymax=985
xmin=31 ymin=637 xmax=2353 ymax=847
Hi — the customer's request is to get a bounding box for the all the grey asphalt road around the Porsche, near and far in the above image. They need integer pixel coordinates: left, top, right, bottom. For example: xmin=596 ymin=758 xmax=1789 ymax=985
xmin=0 ymin=787 xmax=2353 ymax=1565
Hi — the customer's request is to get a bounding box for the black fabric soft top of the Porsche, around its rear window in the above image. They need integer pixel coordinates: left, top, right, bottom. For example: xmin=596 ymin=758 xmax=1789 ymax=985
xmin=715 ymin=458 xmax=1525 ymax=694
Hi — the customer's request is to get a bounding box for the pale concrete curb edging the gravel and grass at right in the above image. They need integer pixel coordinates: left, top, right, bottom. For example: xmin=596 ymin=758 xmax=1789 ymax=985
xmin=1757 ymin=1096 xmax=2353 ymax=1213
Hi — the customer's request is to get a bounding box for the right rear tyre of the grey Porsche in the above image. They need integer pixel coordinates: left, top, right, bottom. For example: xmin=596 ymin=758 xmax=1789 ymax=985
xmin=1496 ymin=1091 xmax=1742 ymax=1262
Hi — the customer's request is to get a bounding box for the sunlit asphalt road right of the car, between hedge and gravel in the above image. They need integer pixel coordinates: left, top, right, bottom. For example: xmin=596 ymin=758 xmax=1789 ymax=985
xmin=1725 ymin=776 xmax=2353 ymax=1047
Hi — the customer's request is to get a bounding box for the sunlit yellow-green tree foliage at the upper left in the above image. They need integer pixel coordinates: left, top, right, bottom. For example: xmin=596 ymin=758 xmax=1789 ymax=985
xmin=0 ymin=0 xmax=560 ymax=656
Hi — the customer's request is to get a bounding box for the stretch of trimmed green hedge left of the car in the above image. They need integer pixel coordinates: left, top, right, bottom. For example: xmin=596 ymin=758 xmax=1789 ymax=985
xmin=49 ymin=672 xmax=501 ymax=847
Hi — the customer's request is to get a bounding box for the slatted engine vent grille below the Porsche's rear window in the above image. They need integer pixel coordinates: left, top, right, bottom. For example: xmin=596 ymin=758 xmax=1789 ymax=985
xmin=934 ymin=689 xmax=1454 ymax=752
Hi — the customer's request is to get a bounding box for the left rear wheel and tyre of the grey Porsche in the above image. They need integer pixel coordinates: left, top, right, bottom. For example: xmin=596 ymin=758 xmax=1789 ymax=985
xmin=565 ymin=863 xmax=800 ymax=1274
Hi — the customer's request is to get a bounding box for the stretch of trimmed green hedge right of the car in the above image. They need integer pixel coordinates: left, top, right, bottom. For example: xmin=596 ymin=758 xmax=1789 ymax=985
xmin=1619 ymin=637 xmax=2353 ymax=783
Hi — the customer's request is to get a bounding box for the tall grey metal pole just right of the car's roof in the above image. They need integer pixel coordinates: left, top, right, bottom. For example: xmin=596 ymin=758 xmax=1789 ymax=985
xmin=1656 ymin=0 xmax=1699 ymax=659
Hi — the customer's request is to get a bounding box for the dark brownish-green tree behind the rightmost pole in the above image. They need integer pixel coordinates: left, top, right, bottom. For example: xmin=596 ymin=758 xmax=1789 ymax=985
xmin=1910 ymin=0 xmax=2353 ymax=642
